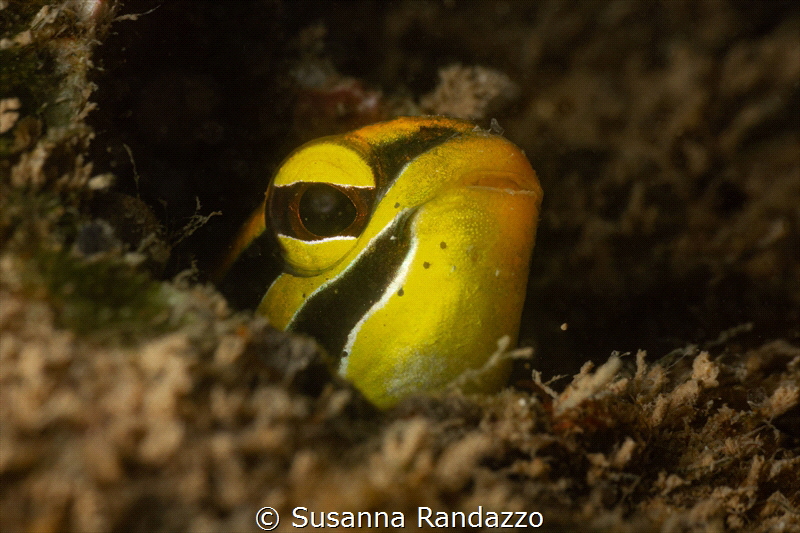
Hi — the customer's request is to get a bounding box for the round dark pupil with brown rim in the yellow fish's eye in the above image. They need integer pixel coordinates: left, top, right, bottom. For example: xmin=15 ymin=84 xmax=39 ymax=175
xmin=299 ymin=183 xmax=358 ymax=237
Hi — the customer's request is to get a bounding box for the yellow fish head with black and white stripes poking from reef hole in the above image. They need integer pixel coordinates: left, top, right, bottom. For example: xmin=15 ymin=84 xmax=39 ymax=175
xmin=222 ymin=117 xmax=542 ymax=407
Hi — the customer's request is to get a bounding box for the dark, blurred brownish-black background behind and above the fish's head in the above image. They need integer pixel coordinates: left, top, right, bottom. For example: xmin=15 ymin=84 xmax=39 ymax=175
xmin=89 ymin=0 xmax=800 ymax=374
